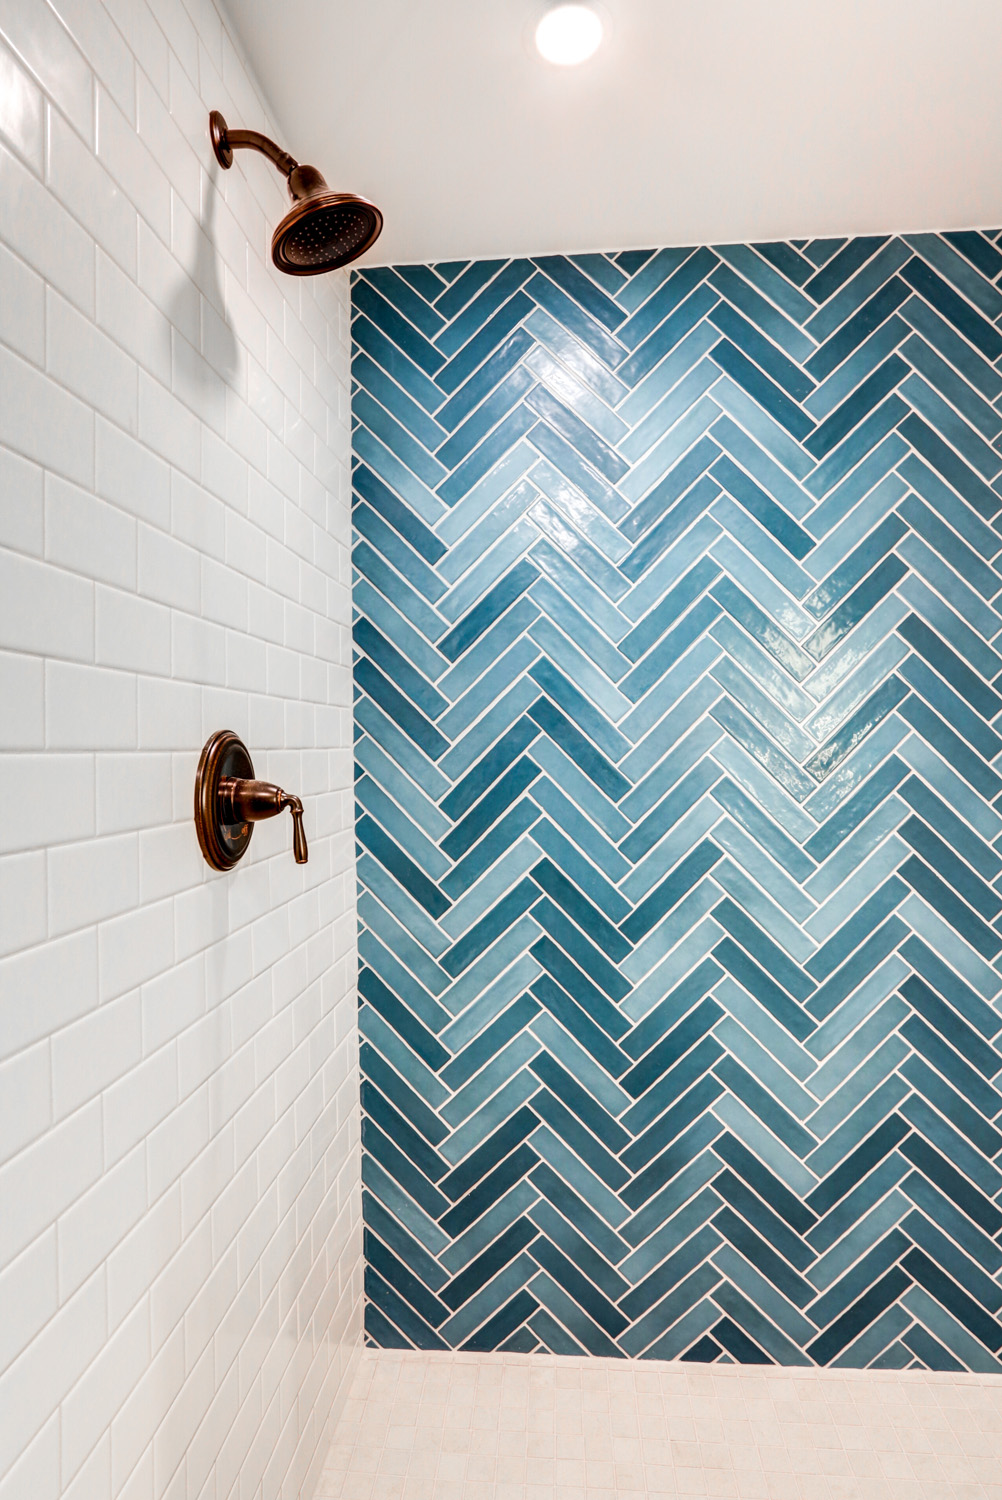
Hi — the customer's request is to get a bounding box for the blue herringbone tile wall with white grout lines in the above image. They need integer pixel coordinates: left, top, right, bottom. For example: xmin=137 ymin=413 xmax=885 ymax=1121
xmin=353 ymin=233 xmax=1002 ymax=1371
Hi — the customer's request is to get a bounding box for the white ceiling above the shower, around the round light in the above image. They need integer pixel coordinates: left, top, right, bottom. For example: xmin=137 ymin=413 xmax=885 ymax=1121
xmin=230 ymin=0 xmax=1002 ymax=264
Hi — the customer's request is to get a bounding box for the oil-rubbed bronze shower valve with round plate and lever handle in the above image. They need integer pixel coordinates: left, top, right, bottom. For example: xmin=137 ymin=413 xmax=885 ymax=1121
xmin=195 ymin=729 xmax=309 ymax=870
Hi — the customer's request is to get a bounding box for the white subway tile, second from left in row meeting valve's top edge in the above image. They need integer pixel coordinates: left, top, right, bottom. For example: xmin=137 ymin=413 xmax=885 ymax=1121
xmin=45 ymin=662 xmax=137 ymax=750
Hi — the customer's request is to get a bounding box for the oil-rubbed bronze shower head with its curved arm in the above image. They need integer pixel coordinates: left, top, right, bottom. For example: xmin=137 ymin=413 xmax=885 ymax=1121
xmin=209 ymin=110 xmax=383 ymax=276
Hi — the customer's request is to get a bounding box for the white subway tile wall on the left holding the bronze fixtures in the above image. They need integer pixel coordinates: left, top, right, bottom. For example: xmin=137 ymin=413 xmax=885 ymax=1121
xmin=0 ymin=0 xmax=362 ymax=1500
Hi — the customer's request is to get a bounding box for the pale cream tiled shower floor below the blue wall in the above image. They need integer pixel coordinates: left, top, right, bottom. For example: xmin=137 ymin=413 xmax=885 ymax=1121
xmin=317 ymin=1349 xmax=1002 ymax=1500
